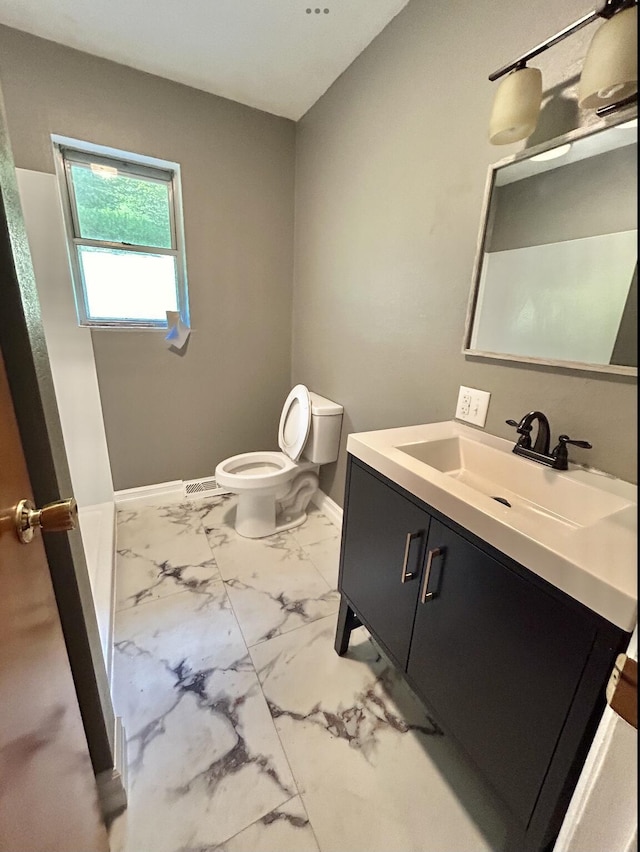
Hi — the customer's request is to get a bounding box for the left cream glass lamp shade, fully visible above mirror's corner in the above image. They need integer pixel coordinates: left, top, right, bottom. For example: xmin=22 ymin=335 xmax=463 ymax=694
xmin=489 ymin=68 xmax=542 ymax=145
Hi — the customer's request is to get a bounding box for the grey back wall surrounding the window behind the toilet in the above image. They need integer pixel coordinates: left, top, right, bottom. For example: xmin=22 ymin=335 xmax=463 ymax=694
xmin=0 ymin=26 xmax=295 ymax=489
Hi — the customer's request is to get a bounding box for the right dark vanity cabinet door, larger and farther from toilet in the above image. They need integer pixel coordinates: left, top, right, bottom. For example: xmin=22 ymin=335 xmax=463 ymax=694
xmin=408 ymin=520 xmax=595 ymax=825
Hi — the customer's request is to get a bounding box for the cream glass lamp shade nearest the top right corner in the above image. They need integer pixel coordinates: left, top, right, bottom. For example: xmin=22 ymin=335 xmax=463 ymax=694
xmin=578 ymin=6 xmax=638 ymax=109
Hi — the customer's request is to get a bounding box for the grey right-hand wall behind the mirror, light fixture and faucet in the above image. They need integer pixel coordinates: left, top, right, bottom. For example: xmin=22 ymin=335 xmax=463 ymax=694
xmin=293 ymin=0 xmax=636 ymax=502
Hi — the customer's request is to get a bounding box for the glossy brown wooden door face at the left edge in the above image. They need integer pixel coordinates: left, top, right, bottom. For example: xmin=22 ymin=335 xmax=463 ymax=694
xmin=0 ymin=354 xmax=109 ymax=852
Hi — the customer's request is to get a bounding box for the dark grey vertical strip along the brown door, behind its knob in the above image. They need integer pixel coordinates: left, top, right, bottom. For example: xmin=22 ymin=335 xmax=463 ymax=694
xmin=0 ymin=85 xmax=116 ymax=792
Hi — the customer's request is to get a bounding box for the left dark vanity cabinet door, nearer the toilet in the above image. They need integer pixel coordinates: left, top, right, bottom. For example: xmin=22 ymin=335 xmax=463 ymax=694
xmin=340 ymin=462 xmax=430 ymax=669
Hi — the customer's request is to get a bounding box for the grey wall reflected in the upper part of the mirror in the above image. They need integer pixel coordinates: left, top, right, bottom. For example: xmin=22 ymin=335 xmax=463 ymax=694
xmin=486 ymin=145 xmax=638 ymax=251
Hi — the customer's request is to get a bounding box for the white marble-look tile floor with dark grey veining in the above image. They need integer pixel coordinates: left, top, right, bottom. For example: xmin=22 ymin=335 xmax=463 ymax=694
xmin=111 ymin=495 xmax=502 ymax=852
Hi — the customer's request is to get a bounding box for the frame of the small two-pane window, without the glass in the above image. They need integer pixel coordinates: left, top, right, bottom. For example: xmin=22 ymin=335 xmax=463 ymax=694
xmin=51 ymin=135 xmax=190 ymax=331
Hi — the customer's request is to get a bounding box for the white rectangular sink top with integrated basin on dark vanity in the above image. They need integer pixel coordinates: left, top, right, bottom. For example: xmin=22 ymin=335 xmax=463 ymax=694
xmin=347 ymin=421 xmax=638 ymax=631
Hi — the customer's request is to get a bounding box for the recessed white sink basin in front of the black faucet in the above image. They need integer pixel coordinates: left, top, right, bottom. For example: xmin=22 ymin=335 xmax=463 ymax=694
xmin=397 ymin=436 xmax=632 ymax=529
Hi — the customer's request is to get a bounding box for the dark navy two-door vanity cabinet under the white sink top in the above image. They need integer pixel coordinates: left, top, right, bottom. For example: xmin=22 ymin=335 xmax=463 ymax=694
xmin=336 ymin=456 xmax=629 ymax=852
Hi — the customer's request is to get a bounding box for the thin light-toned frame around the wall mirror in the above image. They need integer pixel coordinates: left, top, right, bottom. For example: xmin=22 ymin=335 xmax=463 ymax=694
xmin=462 ymin=104 xmax=638 ymax=376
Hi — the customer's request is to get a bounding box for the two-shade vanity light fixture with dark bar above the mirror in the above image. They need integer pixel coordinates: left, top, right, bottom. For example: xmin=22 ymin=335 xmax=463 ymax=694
xmin=489 ymin=0 xmax=638 ymax=145
